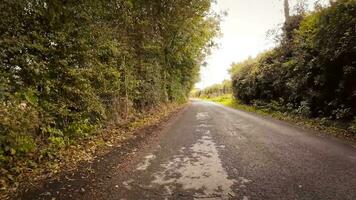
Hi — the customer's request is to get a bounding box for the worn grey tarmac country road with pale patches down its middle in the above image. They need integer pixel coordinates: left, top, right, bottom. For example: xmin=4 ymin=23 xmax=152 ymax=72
xmin=21 ymin=101 xmax=356 ymax=200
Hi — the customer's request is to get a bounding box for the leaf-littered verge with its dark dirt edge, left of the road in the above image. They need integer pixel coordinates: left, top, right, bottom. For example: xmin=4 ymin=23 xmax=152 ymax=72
xmin=0 ymin=104 xmax=186 ymax=199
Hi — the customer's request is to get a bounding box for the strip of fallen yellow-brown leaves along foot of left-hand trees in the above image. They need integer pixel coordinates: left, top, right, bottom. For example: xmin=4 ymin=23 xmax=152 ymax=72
xmin=0 ymin=104 xmax=185 ymax=199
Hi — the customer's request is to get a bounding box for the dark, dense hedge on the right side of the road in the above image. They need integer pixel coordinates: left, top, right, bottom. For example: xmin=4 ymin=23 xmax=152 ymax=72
xmin=230 ymin=0 xmax=356 ymax=126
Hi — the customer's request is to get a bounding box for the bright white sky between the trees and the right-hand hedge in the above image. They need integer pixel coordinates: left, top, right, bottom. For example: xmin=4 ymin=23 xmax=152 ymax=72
xmin=196 ymin=0 xmax=328 ymax=89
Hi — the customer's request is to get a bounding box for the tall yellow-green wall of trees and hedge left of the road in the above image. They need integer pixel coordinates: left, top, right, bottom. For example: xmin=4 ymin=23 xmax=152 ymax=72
xmin=0 ymin=0 xmax=219 ymax=189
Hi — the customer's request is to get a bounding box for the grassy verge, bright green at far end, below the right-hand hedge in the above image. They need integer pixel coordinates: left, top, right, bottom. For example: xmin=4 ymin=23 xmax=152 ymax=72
xmin=204 ymin=94 xmax=356 ymax=142
